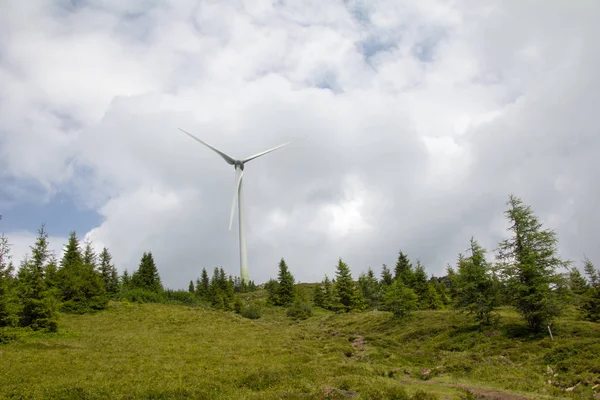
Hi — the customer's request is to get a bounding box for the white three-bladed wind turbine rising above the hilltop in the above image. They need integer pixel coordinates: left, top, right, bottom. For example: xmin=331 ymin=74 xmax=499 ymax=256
xmin=179 ymin=128 xmax=290 ymax=283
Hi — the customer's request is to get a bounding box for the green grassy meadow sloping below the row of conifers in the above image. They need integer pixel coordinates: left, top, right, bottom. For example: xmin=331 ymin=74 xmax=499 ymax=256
xmin=0 ymin=296 xmax=600 ymax=399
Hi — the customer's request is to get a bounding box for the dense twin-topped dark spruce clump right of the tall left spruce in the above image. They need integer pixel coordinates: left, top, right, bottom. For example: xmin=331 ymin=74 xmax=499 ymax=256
xmin=56 ymin=232 xmax=108 ymax=313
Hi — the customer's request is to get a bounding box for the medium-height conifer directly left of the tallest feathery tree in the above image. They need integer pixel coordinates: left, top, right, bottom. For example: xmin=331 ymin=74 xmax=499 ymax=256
xmin=452 ymin=238 xmax=497 ymax=324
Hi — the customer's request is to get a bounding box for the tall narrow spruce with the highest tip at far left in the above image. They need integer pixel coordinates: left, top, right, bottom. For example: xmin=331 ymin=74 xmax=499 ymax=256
xmin=18 ymin=224 xmax=58 ymax=332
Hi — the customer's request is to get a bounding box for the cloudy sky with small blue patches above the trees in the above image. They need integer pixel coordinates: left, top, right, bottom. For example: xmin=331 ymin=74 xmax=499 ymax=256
xmin=0 ymin=0 xmax=600 ymax=288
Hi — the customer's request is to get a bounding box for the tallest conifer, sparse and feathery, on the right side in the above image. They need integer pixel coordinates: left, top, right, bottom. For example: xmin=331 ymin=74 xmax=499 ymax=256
xmin=498 ymin=195 xmax=568 ymax=331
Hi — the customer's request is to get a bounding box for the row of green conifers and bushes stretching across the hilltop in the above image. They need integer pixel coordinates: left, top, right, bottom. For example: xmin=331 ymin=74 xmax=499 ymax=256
xmin=0 ymin=195 xmax=600 ymax=331
